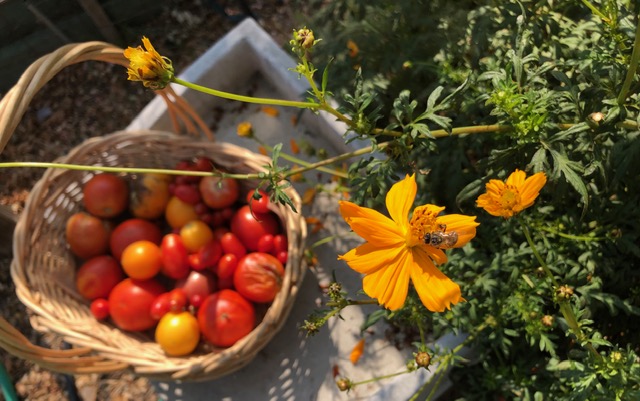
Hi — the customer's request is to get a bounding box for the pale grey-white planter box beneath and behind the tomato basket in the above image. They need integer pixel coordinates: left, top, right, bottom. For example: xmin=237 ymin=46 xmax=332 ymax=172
xmin=128 ymin=19 xmax=460 ymax=401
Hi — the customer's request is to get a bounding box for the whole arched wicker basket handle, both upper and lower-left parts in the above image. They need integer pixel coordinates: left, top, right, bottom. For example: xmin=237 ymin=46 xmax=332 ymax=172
xmin=0 ymin=42 xmax=213 ymax=374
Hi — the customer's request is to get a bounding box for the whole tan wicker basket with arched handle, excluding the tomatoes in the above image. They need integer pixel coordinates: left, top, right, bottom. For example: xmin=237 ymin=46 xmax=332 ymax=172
xmin=0 ymin=42 xmax=306 ymax=381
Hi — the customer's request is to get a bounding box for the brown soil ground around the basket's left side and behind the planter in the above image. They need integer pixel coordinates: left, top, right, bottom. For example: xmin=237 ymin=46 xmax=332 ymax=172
xmin=0 ymin=0 xmax=301 ymax=401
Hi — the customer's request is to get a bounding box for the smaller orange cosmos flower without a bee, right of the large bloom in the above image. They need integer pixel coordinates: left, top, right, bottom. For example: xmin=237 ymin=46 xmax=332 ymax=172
xmin=476 ymin=169 xmax=547 ymax=219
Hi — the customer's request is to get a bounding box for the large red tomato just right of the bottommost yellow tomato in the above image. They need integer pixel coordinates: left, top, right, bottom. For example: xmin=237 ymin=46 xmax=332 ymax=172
xmin=198 ymin=289 xmax=255 ymax=347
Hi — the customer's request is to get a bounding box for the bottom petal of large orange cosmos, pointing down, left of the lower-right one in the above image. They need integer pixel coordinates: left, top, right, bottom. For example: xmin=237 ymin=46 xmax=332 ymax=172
xmin=362 ymin=249 xmax=413 ymax=310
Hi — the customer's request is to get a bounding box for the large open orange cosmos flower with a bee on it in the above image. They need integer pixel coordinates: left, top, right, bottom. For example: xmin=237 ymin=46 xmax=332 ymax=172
xmin=339 ymin=175 xmax=478 ymax=312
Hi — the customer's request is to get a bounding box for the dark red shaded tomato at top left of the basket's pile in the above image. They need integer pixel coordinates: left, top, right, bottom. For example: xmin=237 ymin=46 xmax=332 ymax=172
xmin=82 ymin=173 xmax=129 ymax=218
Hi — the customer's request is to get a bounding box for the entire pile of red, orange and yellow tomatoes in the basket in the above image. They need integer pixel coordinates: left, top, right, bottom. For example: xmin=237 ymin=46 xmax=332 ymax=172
xmin=66 ymin=157 xmax=288 ymax=356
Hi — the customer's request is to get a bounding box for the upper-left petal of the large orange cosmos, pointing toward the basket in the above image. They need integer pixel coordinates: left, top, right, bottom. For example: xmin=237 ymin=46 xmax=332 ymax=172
xmin=339 ymin=201 xmax=404 ymax=248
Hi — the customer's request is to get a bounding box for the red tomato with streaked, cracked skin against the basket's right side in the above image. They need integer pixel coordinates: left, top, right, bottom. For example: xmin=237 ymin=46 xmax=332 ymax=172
xmin=233 ymin=252 xmax=284 ymax=303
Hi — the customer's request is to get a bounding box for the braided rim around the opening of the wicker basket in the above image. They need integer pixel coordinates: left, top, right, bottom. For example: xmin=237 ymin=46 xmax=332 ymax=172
xmin=11 ymin=129 xmax=307 ymax=380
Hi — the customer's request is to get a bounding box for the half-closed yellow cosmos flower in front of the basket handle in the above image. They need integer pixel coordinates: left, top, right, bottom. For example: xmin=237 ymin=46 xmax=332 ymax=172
xmin=124 ymin=37 xmax=174 ymax=90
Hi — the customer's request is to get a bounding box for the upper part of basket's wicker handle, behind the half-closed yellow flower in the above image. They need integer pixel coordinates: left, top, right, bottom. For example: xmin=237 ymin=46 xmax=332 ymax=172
xmin=0 ymin=41 xmax=213 ymax=153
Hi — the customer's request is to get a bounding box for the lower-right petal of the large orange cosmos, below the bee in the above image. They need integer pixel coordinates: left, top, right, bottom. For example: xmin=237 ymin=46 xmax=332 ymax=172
xmin=411 ymin=248 xmax=464 ymax=312
